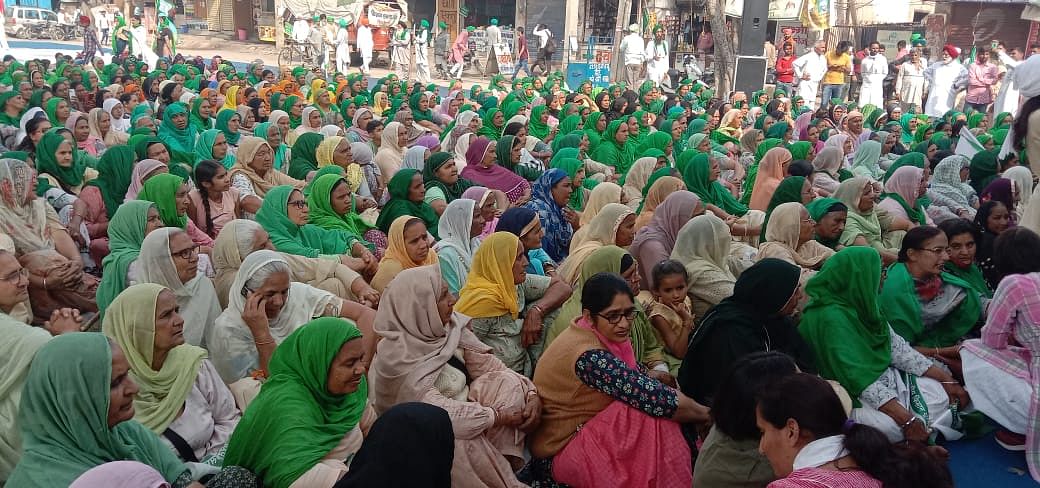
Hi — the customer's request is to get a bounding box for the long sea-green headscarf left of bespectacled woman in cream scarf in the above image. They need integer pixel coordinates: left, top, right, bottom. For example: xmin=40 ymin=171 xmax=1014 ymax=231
xmin=97 ymin=200 xmax=155 ymax=314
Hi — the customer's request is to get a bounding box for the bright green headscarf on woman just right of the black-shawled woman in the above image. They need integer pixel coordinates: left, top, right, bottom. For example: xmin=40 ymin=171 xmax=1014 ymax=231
xmin=798 ymin=246 xmax=892 ymax=406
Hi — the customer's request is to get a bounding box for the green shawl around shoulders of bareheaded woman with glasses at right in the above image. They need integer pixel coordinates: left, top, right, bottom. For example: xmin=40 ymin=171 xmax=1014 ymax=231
xmin=881 ymin=262 xmax=982 ymax=348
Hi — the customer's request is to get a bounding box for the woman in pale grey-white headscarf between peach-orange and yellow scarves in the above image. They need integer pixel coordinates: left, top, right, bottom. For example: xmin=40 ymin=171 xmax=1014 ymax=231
xmin=434 ymin=199 xmax=484 ymax=296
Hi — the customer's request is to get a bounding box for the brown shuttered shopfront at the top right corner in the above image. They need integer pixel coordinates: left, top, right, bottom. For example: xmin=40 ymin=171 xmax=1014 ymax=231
xmin=952 ymin=2 xmax=1030 ymax=50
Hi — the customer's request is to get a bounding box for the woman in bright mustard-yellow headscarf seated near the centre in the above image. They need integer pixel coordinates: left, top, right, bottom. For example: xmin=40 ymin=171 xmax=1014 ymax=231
xmin=458 ymin=232 xmax=571 ymax=377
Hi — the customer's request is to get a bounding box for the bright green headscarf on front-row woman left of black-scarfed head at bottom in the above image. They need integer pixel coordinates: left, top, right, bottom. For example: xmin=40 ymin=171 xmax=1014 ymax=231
xmin=224 ymin=317 xmax=368 ymax=488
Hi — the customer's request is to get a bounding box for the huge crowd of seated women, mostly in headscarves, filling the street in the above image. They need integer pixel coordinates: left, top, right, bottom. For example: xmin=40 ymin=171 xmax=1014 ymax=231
xmin=0 ymin=46 xmax=1040 ymax=488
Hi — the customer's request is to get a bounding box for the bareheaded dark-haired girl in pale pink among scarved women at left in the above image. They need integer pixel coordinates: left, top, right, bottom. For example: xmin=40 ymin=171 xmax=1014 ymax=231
xmin=188 ymin=159 xmax=239 ymax=238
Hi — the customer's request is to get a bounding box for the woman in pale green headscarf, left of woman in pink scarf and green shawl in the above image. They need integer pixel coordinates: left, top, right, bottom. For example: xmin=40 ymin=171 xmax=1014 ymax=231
xmin=834 ymin=177 xmax=914 ymax=264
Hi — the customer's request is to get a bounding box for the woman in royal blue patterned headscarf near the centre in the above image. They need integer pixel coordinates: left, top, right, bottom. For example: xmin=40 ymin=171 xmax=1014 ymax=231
xmin=524 ymin=169 xmax=588 ymax=263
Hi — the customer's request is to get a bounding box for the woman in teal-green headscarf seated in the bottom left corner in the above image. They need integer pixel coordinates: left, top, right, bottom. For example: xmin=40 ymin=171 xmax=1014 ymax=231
xmin=7 ymin=333 xmax=257 ymax=488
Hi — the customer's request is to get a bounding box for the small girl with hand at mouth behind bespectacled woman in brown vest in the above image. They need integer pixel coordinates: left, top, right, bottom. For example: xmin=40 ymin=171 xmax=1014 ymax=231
xmin=646 ymin=259 xmax=694 ymax=376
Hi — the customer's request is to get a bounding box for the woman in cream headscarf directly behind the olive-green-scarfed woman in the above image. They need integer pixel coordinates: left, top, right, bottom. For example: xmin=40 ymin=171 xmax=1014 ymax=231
xmin=560 ymin=203 xmax=635 ymax=284
